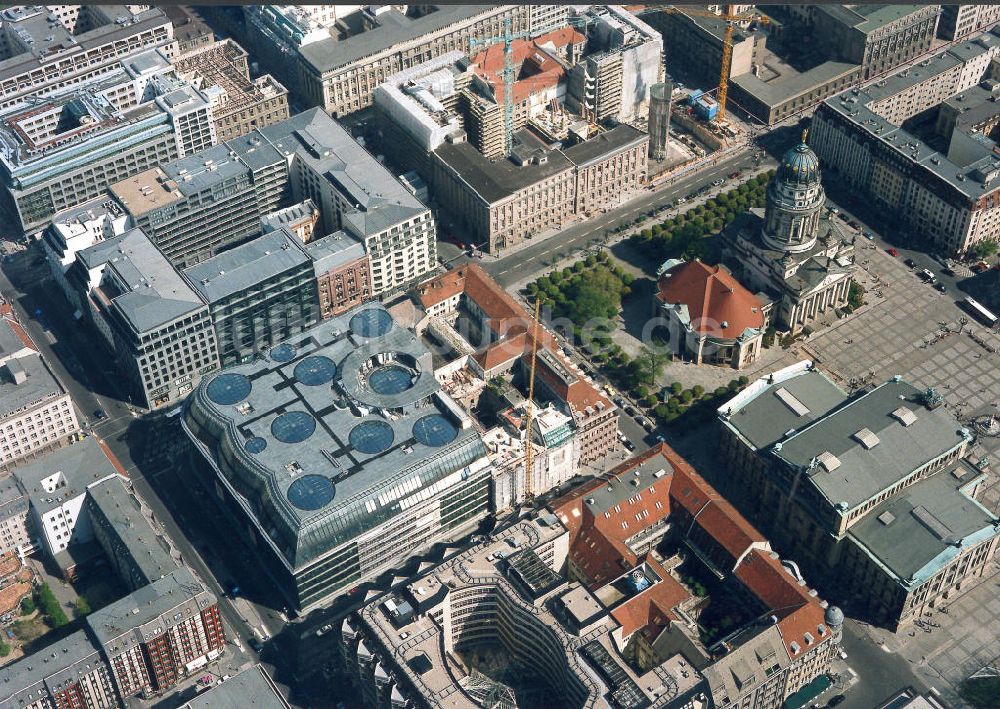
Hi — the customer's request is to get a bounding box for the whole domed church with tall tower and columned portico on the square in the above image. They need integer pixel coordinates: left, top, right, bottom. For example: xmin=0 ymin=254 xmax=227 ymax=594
xmin=723 ymin=143 xmax=855 ymax=334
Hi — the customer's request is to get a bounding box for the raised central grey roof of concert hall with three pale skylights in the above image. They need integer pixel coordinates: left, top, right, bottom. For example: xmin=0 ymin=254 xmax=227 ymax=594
xmin=775 ymin=380 xmax=966 ymax=509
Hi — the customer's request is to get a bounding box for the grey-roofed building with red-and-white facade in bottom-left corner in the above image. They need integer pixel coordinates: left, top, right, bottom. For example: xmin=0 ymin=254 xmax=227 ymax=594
xmin=0 ymin=630 xmax=121 ymax=709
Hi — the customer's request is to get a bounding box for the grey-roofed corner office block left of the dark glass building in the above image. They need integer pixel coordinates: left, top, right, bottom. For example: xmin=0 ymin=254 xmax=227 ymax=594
xmin=67 ymin=229 xmax=219 ymax=409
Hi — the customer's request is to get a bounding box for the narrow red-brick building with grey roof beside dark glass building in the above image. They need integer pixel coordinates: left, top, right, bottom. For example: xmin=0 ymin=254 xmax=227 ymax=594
xmin=306 ymin=231 xmax=372 ymax=320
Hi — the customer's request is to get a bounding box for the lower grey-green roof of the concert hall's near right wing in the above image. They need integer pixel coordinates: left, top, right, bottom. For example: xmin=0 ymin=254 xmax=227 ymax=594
xmin=850 ymin=466 xmax=1000 ymax=587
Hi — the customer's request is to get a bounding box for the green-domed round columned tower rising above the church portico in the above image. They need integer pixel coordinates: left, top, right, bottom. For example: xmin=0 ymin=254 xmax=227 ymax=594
xmin=763 ymin=133 xmax=826 ymax=253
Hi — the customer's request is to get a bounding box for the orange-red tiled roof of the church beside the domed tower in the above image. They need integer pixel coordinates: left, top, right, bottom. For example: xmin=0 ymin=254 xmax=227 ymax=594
xmin=657 ymin=261 xmax=764 ymax=339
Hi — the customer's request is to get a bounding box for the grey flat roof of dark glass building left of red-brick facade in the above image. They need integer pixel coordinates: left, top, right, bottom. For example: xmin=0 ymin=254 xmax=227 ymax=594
xmin=184 ymin=229 xmax=311 ymax=305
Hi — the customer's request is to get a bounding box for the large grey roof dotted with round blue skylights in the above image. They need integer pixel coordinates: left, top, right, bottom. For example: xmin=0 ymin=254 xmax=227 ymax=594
xmin=189 ymin=303 xmax=486 ymax=566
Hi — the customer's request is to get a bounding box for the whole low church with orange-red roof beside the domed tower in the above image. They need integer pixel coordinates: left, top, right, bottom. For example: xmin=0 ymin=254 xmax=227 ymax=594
xmin=653 ymin=261 xmax=770 ymax=369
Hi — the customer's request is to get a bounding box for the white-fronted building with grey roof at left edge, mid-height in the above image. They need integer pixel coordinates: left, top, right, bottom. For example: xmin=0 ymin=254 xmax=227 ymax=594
xmin=0 ymin=354 xmax=80 ymax=466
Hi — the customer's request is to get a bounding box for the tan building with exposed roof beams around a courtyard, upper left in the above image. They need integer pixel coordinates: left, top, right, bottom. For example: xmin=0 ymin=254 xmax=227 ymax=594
xmin=174 ymin=39 xmax=288 ymax=143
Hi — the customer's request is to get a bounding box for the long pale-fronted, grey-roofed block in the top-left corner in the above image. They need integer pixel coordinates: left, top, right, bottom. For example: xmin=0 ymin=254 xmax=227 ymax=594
xmin=0 ymin=5 xmax=176 ymax=111
